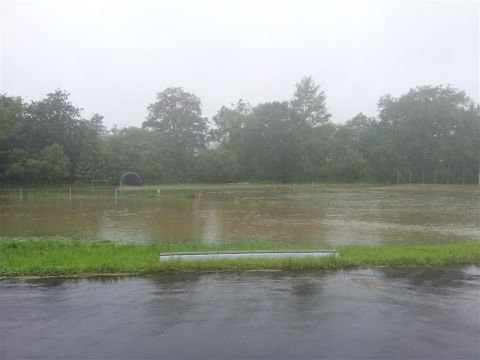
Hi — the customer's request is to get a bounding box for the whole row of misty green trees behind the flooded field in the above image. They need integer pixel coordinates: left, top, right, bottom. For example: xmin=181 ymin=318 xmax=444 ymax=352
xmin=0 ymin=77 xmax=480 ymax=184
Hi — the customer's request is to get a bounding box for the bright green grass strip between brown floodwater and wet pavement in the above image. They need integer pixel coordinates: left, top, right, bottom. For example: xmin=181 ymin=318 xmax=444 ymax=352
xmin=0 ymin=238 xmax=480 ymax=277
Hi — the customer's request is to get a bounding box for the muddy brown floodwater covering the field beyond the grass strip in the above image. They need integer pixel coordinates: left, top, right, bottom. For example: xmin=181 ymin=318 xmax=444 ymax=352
xmin=0 ymin=185 xmax=480 ymax=245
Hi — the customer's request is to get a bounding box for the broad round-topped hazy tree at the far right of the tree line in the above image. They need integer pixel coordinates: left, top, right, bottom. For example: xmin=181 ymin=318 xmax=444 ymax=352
xmin=379 ymin=86 xmax=479 ymax=180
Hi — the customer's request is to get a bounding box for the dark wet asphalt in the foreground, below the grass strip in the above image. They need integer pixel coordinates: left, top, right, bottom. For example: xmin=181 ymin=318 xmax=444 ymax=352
xmin=0 ymin=267 xmax=480 ymax=359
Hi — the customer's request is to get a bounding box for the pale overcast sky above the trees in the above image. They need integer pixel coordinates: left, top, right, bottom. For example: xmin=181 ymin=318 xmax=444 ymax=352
xmin=0 ymin=0 xmax=479 ymax=127
